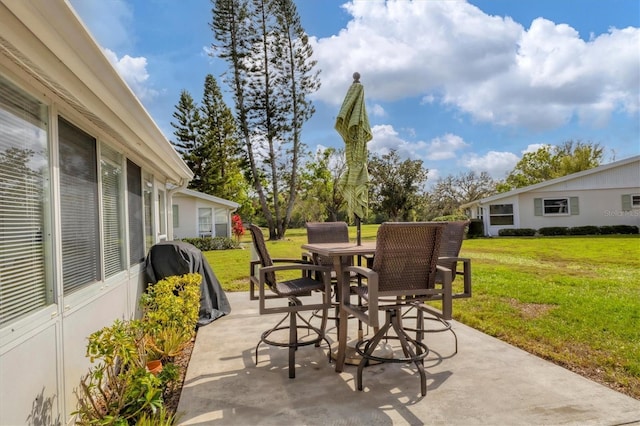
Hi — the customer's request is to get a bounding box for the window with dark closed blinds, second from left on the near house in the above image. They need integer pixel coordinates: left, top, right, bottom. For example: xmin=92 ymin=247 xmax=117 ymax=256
xmin=58 ymin=117 xmax=101 ymax=294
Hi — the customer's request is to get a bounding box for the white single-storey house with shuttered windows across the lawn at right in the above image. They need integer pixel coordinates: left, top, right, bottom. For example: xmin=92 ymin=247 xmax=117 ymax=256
xmin=461 ymin=155 xmax=640 ymax=236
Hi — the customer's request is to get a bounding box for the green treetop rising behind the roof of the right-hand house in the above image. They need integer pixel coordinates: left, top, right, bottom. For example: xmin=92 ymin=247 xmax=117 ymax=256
xmin=497 ymin=141 xmax=604 ymax=192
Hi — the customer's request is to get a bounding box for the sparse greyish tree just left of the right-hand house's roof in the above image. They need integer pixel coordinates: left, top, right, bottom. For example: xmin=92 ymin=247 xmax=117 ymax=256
xmin=427 ymin=171 xmax=496 ymax=219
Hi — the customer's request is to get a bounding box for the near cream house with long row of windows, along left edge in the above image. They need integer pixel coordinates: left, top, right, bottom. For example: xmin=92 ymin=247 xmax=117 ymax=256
xmin=0 ymin=0 xmax=193 ymax=425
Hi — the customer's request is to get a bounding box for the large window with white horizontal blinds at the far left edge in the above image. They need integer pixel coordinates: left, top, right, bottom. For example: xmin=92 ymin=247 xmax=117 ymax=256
xmin=0 ymin=77 xmax=53 ymax=327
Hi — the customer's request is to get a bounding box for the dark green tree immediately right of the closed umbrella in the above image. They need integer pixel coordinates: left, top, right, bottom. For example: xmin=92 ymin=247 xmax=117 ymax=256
xmin=369 ymin=150 xmax=428 ymax=221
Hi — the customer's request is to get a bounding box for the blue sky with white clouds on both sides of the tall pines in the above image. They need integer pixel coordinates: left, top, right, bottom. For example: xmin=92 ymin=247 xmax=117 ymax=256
xmin=71 ymin=0 xmax=640 ymax=184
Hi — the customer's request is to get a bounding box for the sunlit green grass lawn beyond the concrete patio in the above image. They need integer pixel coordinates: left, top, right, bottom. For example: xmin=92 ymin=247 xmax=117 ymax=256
xmin=205 ymin=225 xmax=640 ymax=399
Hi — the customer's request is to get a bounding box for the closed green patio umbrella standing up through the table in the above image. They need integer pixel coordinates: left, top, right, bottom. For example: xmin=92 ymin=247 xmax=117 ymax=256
xmin=335 ymin=72 xmax=373 ymax=245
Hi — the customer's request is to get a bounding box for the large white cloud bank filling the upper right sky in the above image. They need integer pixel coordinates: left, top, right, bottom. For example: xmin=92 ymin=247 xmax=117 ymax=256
xmin=312 ymin=0 xmax=640 ymax=130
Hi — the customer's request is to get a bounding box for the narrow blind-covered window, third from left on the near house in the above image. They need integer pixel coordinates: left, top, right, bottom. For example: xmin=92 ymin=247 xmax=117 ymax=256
xmin=100 ymin=144 xmax=125 ymax=278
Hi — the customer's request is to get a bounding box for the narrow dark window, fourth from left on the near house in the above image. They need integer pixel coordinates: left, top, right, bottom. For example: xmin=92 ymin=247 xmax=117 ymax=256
xmin=127 ymin=160 xmax=144 ymax=265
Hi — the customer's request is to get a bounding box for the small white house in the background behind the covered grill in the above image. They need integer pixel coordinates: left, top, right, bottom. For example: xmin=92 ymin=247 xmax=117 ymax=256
xmin=172 ymin=189 xmax=240 ymax=238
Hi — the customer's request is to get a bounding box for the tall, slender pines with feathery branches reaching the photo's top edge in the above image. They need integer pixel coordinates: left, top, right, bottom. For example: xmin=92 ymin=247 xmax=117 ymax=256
xmin=211 ymin=0 xmax=319 ymax=239
